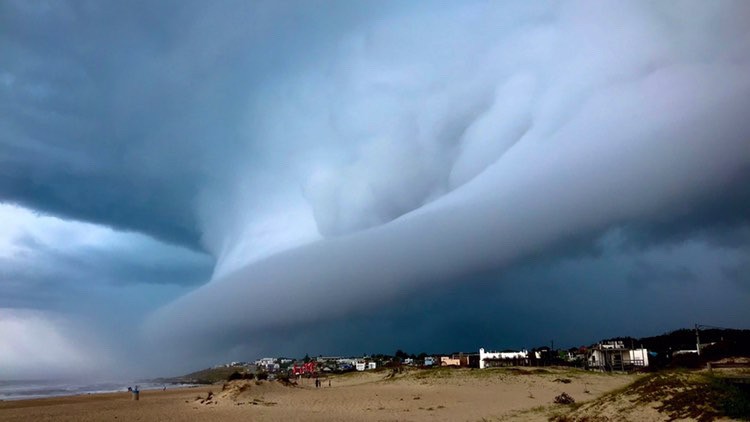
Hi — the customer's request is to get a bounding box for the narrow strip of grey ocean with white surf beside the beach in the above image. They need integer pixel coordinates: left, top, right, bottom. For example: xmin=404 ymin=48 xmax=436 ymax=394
xmin=0 ymin=381 xmax=195 ymax=400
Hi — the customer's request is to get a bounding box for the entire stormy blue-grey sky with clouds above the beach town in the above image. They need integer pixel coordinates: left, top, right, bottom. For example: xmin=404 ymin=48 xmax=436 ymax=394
xmin=0 ymin=0 xmax=750 ymax=379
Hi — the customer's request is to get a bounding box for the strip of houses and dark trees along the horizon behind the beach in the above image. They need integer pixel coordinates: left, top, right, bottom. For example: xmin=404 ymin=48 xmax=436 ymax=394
xmin=213 ymin=325 xmax=750 ymax=379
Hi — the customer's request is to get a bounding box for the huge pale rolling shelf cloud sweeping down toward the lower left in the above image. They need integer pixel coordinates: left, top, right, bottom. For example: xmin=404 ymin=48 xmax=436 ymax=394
xmin=147 ymin=2 xmax=750 ymax=352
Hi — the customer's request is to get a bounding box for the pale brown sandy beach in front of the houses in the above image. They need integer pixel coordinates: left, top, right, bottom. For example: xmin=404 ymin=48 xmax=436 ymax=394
xmin=0 ymin=368 xmax=638 ymax=421
